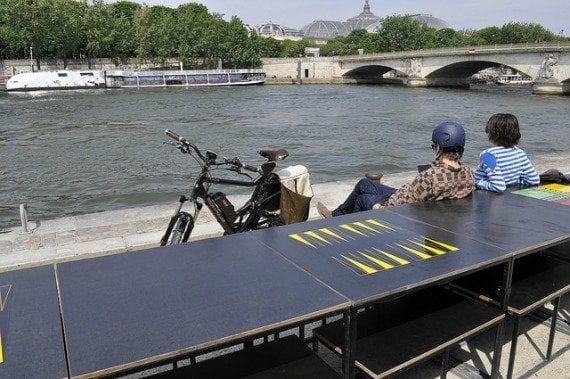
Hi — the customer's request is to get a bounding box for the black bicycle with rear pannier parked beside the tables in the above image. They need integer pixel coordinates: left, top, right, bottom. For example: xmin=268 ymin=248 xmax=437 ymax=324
xmin=160 ymin=129 xmax=310 ymax=246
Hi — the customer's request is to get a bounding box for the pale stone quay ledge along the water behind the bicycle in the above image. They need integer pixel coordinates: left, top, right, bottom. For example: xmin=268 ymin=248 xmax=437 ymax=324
xmin=0 ymin=163 xmax=569 ymax=272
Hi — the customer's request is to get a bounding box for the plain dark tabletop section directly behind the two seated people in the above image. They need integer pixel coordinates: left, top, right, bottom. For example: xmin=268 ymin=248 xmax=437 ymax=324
xmin=382 ymin=188 xmax=570 ymax=255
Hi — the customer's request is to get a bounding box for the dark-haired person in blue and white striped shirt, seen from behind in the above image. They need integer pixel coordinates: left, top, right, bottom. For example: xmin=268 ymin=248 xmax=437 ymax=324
xmin=475 ymin=113 xmax=540 ymax=192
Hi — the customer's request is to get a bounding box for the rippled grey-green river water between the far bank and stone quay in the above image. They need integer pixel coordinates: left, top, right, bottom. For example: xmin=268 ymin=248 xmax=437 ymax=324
xmin=0 ymin=85 xmax=570 ymax=229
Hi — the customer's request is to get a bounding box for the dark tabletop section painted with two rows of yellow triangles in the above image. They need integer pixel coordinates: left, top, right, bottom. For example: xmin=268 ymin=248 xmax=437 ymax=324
xmin=253 ymin=211 xmax=510 ymax=305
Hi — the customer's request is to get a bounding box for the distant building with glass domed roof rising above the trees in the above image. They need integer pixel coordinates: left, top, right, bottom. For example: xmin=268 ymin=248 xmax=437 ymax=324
xmin=251 ymin=0 xmax=451 ymax=43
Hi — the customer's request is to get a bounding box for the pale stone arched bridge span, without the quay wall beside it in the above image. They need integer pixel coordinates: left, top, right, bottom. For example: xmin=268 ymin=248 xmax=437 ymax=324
xmin=339 ymin=44 xmax=570 ymax=94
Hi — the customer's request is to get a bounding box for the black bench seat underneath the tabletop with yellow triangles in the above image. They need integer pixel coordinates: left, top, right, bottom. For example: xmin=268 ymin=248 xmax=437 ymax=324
xmin=314 ymin=290 xmax=504 ymax=377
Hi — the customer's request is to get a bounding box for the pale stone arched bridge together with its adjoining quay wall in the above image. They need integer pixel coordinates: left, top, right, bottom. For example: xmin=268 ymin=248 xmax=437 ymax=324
xmin=264 ymin=42 xmax=570 ymax=95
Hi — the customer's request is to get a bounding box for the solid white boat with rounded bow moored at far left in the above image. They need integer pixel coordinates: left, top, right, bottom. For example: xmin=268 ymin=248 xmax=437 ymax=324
xmin=6 ymin=70 xmax=106 ymax=92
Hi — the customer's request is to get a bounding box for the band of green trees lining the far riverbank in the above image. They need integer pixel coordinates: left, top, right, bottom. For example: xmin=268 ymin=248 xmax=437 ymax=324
xmin=0 ymin=0 xmax=569 ymax=68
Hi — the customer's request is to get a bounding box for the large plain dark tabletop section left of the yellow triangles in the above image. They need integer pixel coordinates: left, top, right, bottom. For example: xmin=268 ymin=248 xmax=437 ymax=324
xmin=57 ymin=233 xmax=349 ymax=376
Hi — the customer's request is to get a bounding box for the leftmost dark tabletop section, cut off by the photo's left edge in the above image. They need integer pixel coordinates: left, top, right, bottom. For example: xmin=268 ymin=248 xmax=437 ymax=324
xmin=0 ymin=266 xmax=67 ymax=378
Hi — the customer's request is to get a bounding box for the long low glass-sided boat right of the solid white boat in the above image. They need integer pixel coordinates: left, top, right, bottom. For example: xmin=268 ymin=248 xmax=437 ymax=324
xmin=107 ymin=69 xmax=265 ymax=88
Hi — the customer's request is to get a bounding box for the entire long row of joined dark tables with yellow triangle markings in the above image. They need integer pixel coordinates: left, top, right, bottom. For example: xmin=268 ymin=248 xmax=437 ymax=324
xmin=0 ymin=186 xmax=570 ymax=378
